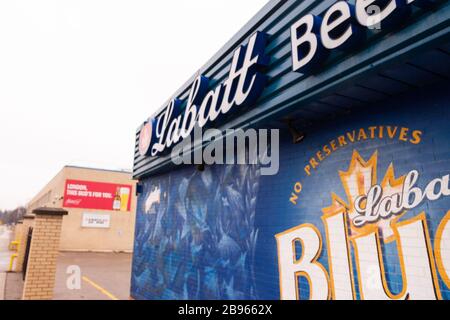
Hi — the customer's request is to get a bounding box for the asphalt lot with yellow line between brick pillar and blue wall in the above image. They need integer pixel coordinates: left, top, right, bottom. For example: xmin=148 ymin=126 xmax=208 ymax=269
xmin=54 ymin=252 xmax=132 ymax=300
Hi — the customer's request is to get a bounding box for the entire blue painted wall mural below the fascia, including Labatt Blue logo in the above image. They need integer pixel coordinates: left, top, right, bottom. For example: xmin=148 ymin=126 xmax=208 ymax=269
xmin=132 ymin=85 xmax=450 ymax=299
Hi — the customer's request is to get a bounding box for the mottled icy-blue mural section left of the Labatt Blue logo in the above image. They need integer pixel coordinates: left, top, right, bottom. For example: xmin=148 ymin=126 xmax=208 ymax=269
xmin=132 ymin=166 xmax=260 ymax=299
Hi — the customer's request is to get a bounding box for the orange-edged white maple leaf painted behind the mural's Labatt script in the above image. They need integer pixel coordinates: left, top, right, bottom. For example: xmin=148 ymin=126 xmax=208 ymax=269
xmin=322 ymin=150 xmax=406 ymax=242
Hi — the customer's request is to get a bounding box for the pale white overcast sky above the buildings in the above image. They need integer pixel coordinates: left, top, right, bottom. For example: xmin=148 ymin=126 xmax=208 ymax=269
xmin=0 ymin=0 xmax=267 ymax=209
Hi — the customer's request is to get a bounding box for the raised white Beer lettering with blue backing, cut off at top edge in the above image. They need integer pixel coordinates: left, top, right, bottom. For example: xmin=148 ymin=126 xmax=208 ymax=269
xmin=291 ymin=0 xmax=440 ymax=72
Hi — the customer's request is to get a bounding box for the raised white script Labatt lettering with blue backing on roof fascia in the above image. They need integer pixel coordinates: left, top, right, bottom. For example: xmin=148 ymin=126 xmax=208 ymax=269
xmin=139 ymin=32 xmax=268 ymax=156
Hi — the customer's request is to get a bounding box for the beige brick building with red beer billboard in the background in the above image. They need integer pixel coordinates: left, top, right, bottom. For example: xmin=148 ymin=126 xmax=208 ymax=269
xmin=27 ymin=166 xmax=136 ymax=252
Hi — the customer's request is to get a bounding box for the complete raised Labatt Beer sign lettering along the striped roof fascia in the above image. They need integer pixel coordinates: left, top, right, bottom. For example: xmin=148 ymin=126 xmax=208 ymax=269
xmin=139 ymin=0 xmax=439 ymax=157
